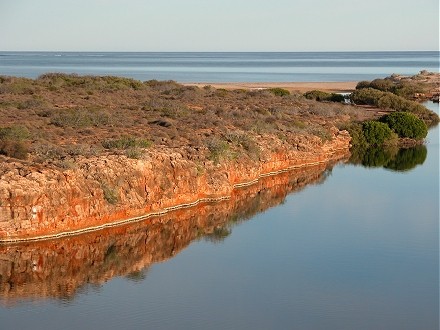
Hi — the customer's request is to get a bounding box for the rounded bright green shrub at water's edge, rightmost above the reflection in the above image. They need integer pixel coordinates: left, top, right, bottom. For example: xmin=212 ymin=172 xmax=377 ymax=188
xmin=380 ymin=112 xmax=428 ymax=139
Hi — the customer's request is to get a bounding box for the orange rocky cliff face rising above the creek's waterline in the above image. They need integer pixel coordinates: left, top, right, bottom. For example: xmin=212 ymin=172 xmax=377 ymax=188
xmin=0 ymin=129 xmax=350 ymax=241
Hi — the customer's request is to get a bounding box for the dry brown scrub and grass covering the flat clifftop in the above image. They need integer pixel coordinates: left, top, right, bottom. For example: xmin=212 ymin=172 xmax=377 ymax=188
xmin=0 ymin=74 xmax=368 ymax=167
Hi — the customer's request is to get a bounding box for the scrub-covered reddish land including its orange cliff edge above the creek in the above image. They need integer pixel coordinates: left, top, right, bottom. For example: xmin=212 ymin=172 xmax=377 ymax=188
xmin=0 ymin=74 xmax=438 ymax=241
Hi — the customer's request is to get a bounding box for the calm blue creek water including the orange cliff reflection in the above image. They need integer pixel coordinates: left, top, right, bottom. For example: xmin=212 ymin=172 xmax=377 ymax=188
xmin=0 ymin=103 xmax=439 ymax=330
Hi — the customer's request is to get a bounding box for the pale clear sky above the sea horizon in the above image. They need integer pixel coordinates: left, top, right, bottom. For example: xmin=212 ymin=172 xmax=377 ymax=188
xmin=0 ymin=0 xmax=439 ymax=51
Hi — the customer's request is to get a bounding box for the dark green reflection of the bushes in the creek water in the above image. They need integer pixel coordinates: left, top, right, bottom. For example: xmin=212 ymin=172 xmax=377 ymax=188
xmin=350 ymin=145 xmax=428 ymax=172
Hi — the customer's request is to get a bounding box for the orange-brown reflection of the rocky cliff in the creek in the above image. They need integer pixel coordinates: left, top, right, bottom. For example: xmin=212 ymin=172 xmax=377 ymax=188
xmin=0 ymin=165 xmax=331 ymax=304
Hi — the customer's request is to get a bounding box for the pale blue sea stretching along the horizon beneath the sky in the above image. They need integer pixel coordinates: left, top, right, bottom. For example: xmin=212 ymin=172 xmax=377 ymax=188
xmin=0 ymin=51 xmax=439 ymax=82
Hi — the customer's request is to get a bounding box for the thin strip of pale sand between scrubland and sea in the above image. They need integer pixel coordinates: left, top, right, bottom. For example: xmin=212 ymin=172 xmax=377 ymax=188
xmin=183 ymin=81 xmax=358 ymax=93
